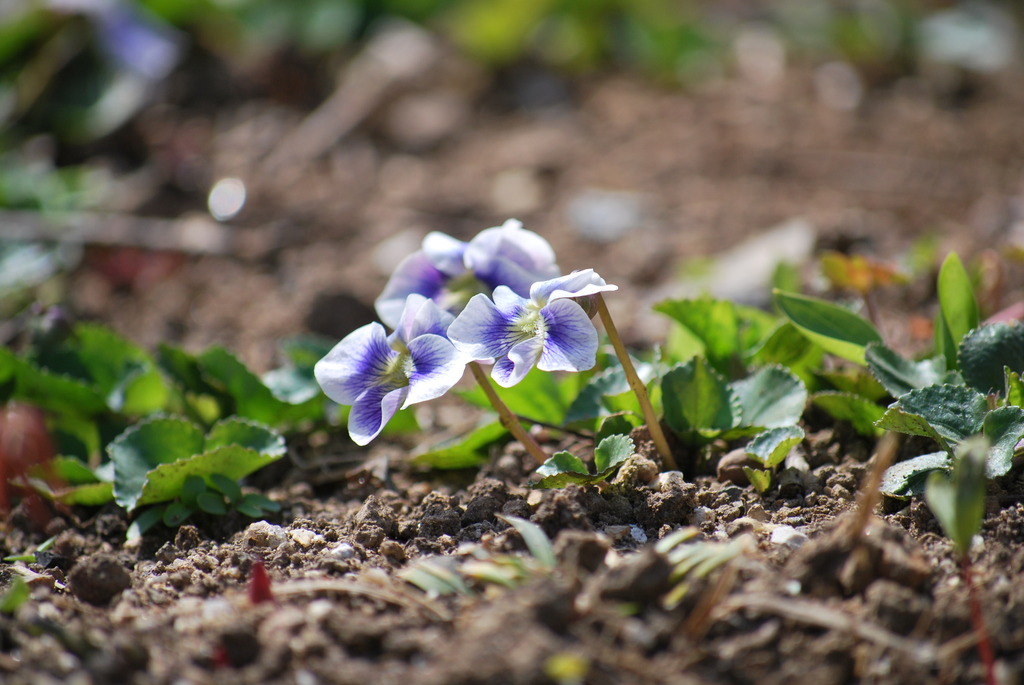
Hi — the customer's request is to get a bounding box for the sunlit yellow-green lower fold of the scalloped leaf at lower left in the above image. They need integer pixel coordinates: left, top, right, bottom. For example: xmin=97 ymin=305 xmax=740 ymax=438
xmin=135 ymin=444 xmax=281 ymax=506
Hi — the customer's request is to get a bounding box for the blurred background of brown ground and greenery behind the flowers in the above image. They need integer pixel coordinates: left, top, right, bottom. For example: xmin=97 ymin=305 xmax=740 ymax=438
xmin=0 ymin=0 xmax=1024 ymax=369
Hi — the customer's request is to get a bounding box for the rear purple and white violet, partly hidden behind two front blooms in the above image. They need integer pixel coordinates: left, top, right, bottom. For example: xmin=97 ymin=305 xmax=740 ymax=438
xmin=376 ymin=219 xmax=559 ymax=327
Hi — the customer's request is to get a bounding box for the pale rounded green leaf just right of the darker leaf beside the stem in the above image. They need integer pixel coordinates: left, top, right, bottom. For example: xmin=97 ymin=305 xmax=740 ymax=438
xmin=730 ymin=367 xmax=807 ymax=428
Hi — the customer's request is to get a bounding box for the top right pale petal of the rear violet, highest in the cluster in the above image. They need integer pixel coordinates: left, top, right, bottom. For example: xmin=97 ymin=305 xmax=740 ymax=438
xmin=465 ymin=219 xmax=559 ymax=296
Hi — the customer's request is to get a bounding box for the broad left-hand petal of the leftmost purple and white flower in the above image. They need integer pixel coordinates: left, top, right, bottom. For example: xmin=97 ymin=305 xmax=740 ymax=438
xmin=313 ymin=323 xmax=396 ymax=404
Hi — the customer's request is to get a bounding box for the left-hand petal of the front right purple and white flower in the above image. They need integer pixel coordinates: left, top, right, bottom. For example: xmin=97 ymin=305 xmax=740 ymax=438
xmin=447 ymin=292 xmax=525 ymax=361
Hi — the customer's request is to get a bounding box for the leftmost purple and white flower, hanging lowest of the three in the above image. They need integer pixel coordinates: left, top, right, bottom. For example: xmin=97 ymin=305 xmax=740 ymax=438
xmin=313 ymin=295 xmax=466 ymax=444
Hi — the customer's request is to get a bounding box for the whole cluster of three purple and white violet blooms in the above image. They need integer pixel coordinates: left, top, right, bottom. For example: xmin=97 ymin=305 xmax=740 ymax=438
xmin=313 ymin=219 xmax=617 ymax=444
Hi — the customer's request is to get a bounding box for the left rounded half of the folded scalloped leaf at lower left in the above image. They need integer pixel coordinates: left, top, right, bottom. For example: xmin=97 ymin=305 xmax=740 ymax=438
xmin=106 ymin=418 xmax=203 ymax=511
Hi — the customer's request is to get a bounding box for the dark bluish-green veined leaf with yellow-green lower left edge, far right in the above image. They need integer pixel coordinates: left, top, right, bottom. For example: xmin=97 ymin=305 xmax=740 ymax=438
xmin=876 ymin=385 xmax=988 ymax=452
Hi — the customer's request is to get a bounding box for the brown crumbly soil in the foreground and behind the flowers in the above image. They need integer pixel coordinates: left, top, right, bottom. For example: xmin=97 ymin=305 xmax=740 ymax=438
xmin=0 ymin=33 xmax=1024 ymax=685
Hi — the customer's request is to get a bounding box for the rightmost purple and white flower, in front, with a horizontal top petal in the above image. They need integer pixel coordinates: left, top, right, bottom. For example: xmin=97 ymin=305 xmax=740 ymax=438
xmin=447 ymin=269 xmax=618 ymax=388
